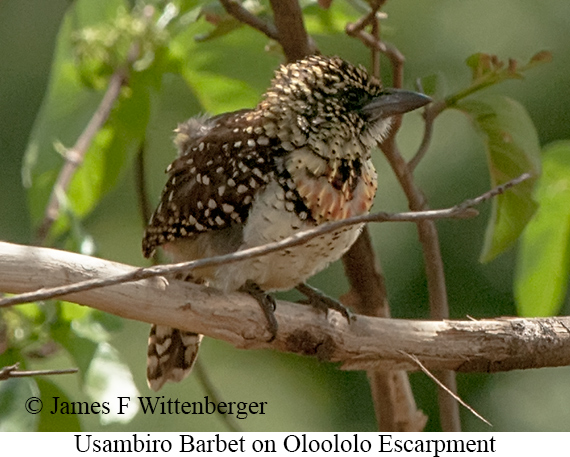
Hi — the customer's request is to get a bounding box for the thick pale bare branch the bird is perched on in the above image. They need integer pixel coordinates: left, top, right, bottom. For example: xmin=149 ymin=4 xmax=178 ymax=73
xmin=0 ymin=243 xmax=570 ymax=372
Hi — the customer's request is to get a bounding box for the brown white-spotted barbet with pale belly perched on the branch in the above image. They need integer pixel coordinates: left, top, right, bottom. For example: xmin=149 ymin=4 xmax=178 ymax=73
xmin=142 ymin=55 xmax=431 ymax=390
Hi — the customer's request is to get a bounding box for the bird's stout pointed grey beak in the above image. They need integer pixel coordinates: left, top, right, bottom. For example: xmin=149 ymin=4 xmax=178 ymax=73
xmin=362 ymin=89 xmax=432 ymax=122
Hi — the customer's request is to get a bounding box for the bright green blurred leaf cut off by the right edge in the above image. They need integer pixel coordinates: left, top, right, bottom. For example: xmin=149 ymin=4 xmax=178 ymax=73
xmin=514 ymin=141 xmax=570 ymax=316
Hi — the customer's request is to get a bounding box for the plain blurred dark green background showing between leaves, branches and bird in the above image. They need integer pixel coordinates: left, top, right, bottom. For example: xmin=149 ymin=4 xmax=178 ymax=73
xmin=0 ymin=0 xmax=570 ymax=431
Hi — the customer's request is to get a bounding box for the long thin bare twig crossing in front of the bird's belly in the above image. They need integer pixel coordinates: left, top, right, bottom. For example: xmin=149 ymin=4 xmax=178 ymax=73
xmin=0 ymin=174 xmax=530 ymax=308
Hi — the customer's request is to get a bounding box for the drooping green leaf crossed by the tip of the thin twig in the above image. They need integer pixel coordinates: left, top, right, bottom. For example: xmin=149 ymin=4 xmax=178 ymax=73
xmin=456 ymin=96 xmax=540 ymax=262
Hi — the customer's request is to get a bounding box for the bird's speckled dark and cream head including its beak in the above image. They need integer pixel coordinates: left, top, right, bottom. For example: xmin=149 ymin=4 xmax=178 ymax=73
xmin=258 ymin=55 xmax=431 ymax=157
